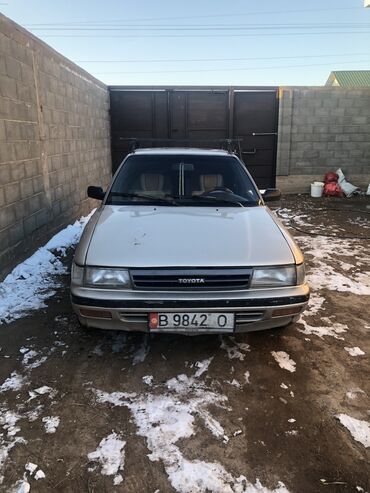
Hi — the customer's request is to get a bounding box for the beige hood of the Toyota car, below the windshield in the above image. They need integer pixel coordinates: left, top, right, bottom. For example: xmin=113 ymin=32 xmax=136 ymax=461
xmin=84 ymin=206 xmax=294 ymax=267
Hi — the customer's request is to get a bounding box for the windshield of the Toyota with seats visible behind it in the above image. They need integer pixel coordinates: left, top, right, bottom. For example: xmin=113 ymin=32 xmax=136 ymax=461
xmin=106 ymin=154 xmax=260 ymax=207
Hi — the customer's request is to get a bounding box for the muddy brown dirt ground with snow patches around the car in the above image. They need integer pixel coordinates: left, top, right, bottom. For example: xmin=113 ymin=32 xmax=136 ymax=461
xmin=0 ymin=196 xmax=370 ymax=493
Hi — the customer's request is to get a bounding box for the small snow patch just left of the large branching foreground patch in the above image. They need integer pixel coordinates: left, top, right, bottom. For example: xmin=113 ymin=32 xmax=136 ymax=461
xmin=87 ymin=432 xmax=126 ymax=485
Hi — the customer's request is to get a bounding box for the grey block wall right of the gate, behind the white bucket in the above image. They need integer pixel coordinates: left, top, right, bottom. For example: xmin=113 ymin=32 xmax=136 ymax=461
xmin=277 ymin=87 xmax=370 ymax=192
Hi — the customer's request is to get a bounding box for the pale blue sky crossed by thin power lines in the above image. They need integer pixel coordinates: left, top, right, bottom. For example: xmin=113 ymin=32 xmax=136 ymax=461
xmin=0 ymin=0 xmax=370 ymax=86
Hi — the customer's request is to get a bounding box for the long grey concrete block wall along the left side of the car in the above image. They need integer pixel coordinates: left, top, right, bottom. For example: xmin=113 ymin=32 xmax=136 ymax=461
xmin=0 ymin=15 xmax=111 ymax=279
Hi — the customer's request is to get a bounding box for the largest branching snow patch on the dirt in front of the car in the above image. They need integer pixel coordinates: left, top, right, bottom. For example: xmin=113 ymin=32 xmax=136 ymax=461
xmin=94 ymin=359 xmax=287 ymax=493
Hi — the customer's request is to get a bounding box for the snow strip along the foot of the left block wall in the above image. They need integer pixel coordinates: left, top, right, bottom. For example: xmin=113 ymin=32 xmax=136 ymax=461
xmin=0 ymin=211 xmax=94 ymax=325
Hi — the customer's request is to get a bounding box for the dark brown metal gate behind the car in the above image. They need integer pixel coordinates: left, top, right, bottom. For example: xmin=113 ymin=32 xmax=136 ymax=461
xmin=110 ymin=86 xmax=278 ymax=188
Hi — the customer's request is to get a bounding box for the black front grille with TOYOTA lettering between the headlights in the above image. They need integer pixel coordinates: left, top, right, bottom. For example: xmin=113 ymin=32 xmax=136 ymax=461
xmin=131 ymin=268 xmax=252 ymax=291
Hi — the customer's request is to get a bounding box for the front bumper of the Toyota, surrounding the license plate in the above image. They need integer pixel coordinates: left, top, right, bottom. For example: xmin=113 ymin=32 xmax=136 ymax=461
xmin=71 ymin=284 xmax=309 ymax=334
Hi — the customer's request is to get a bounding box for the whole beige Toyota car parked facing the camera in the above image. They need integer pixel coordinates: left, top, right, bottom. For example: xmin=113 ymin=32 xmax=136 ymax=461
xmin=71 ymin=148 xmax=309 ymax=334
